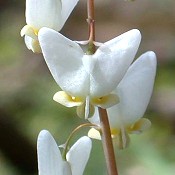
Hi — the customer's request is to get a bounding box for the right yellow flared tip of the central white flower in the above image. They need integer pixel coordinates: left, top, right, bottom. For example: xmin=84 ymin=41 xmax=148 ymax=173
xmin=91 ymin=94 xmax=120 ymax=109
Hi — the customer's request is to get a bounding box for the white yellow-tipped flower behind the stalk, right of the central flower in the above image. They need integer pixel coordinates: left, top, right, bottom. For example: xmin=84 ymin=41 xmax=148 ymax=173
xmin=88 ymin=51 xmax=156 ymax=148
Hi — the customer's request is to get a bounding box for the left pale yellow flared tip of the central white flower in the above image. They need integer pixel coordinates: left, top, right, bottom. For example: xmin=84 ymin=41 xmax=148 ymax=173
xmin=53 ymin=91 xmax=84 ymax=107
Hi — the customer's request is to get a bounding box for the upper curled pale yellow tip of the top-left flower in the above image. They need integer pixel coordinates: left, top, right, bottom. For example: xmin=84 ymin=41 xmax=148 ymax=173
xmin=20 ymin=25 xmax=39 ymax=40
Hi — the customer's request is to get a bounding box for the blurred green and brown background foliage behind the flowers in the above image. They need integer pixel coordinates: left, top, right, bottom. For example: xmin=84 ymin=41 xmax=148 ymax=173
xmin=0 ymin=0 xmax=175 ymax=175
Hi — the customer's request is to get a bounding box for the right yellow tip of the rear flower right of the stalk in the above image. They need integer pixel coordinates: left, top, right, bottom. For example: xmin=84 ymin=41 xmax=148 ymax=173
xmin=127 ymin=118 xmax=151 ymax=134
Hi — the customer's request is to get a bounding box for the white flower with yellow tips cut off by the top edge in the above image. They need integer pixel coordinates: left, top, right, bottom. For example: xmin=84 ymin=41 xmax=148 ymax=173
xmin=21 ymin=0 xmax=78 ymax=53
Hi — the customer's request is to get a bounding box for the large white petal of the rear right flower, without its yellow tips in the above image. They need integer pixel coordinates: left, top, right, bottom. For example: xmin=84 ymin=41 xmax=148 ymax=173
xmin=108 ymin=51 xmax=156 ymax=127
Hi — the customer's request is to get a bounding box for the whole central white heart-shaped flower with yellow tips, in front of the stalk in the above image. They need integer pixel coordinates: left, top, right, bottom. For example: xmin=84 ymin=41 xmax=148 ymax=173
xmin=39 ymin=28 xmax=141 ymax=117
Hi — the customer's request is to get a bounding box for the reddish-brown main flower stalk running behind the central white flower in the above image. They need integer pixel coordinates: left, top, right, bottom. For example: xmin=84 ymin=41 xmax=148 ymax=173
xmin=87 ymin=0 xmax=118 ymax=175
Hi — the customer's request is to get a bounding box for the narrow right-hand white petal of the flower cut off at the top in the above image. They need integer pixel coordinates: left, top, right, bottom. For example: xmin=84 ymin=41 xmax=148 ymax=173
xmin=61 ymin=0 xmax=79 ymax=26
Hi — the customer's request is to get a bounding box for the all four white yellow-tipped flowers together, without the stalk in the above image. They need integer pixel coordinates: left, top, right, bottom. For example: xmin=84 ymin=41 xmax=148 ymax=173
xmin=21 ymin=0 xmax=156 ymax=175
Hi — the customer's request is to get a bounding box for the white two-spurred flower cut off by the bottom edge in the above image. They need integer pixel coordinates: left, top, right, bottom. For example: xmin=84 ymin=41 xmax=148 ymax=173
xmin=37 ymin=130 xmax=92 ymax=175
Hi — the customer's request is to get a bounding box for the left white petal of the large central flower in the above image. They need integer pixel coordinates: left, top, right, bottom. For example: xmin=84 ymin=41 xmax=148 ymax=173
xmin=39 ymin=28 xmax=89 ymax=97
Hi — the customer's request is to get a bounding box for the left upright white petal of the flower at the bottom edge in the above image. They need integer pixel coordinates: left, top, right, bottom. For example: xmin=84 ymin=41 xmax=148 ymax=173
xmin=37 ymin=130 xmax=63 ymax=175
